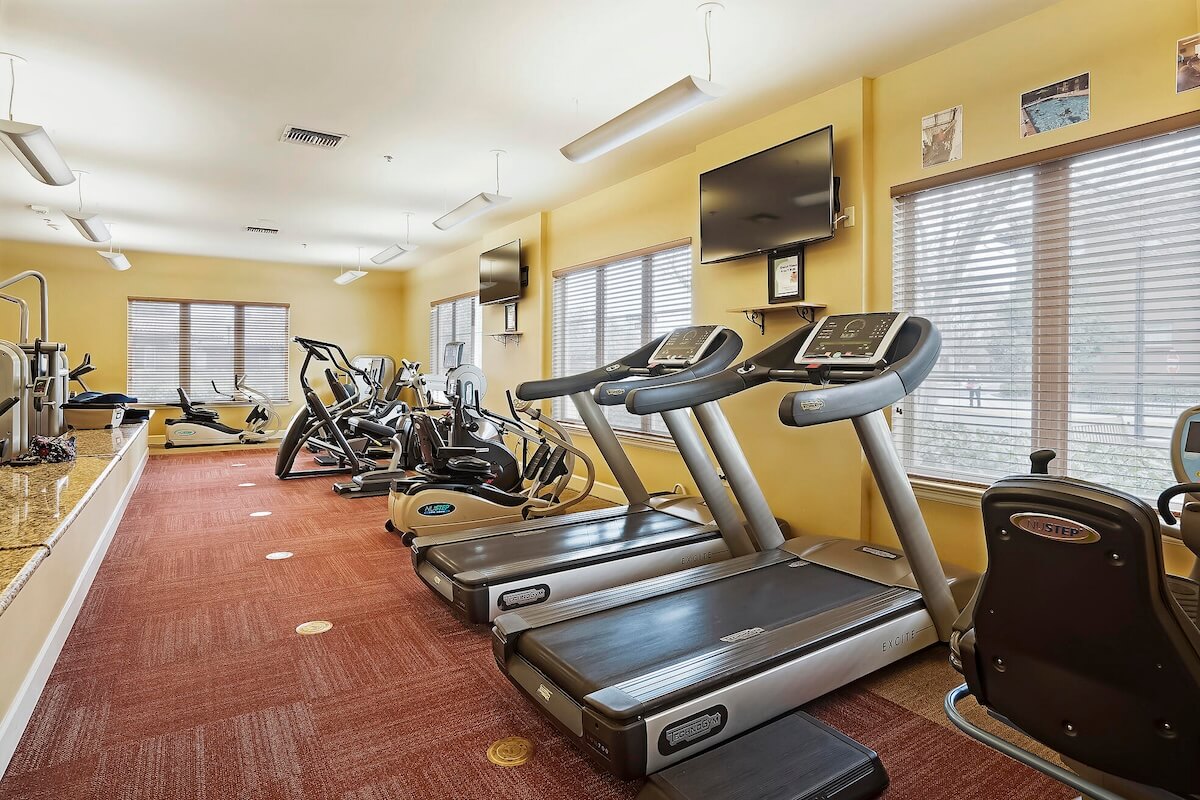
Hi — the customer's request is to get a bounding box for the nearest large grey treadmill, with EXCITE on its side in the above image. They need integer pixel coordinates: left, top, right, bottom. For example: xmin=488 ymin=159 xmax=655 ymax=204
xmin=492 ymin=313 xmax=978 ymax=782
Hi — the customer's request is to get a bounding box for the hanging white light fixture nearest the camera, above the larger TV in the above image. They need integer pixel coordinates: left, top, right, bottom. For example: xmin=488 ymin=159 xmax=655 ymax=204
xmin=559 ymin=2 xmax=725 ymax=164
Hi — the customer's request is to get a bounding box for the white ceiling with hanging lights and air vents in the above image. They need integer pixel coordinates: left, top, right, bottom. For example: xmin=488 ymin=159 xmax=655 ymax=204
xmin=0 ymin=0 xmax=1052 ymax=269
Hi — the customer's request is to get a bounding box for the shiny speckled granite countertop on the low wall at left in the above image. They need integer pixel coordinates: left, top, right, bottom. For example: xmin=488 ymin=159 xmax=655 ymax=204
xmin=0 ymin=422 xmax=146 ymax=610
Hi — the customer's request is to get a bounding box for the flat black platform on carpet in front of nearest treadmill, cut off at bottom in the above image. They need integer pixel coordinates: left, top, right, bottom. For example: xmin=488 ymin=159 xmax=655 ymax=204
xmin=637 ymin=711 xmax=888 ymax=800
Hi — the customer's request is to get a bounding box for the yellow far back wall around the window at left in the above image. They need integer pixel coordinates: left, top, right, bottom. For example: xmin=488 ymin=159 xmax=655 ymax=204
xmin=0 ymin=241 xmax=404 ymax=434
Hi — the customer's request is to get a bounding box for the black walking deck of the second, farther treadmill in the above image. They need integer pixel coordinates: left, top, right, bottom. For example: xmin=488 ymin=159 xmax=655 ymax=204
xmin=426 ymin=511 xmax=720 ymax=587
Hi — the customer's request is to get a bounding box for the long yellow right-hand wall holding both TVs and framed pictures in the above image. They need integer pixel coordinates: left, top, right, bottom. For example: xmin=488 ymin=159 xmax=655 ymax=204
xmin=404 ymin=0 xmax=1200 ymax=575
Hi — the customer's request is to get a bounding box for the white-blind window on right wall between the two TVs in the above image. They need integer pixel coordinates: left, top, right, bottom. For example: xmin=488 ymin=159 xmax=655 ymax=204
xmin=553 ymin=245 xmax=691 ymax=435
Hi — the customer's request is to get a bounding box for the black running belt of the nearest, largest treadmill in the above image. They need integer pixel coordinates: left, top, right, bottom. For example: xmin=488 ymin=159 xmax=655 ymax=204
xmin=517 ymin=559 xmax=888 ymax=699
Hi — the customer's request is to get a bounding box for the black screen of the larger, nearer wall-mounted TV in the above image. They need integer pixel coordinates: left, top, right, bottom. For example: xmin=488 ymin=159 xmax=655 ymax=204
xmin=700 ymin=126 xmax=834 ymax=264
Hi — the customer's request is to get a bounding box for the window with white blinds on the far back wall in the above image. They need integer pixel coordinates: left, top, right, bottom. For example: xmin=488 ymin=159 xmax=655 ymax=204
xmin=128 ymin=297 xmax=288 ymax=403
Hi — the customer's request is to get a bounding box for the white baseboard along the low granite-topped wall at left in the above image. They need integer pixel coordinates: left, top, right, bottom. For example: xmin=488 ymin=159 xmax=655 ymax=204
xmin=0 ymin=451 xmax=150 ymax=776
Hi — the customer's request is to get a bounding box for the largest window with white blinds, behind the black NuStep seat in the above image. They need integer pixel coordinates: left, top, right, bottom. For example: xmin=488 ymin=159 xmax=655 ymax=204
xmin=893 ymin=128 xmax=1200 ymax=498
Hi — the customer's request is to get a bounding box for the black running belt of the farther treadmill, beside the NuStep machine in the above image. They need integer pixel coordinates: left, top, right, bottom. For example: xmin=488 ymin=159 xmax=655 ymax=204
xmin=428 ymin=511 xmax=716 ymax=576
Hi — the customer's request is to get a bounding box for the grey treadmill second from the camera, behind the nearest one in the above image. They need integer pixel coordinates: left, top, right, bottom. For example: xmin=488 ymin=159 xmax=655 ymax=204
xmin=412 ymin=325 xmax=782 ymax=624
